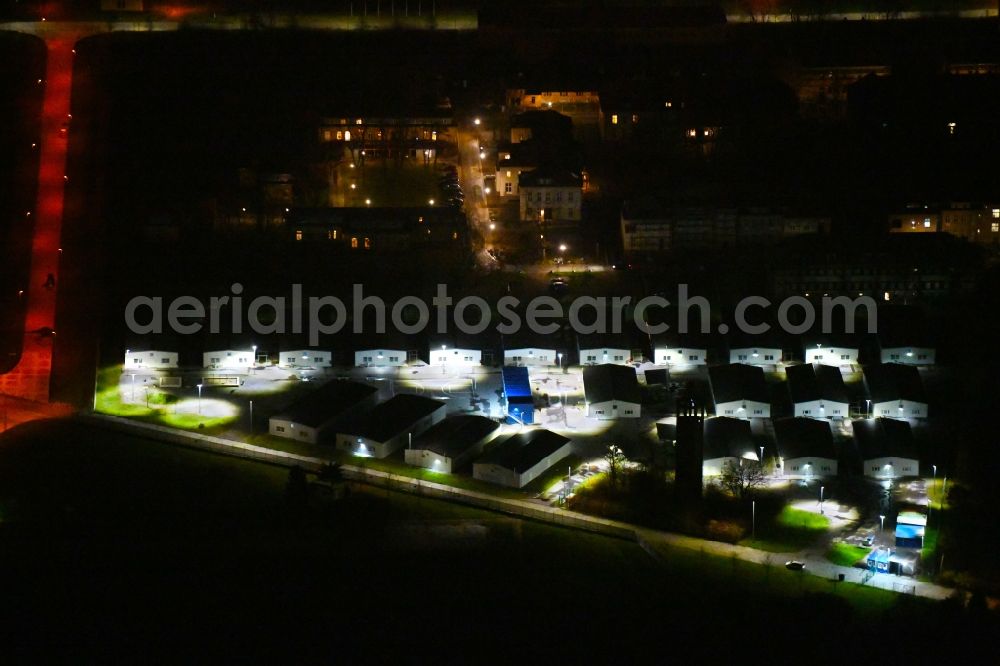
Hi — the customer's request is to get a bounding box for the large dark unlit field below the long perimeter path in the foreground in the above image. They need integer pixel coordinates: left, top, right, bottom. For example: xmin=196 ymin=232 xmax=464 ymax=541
xmin=0 ymin=421 xmax=988 ymax=663
